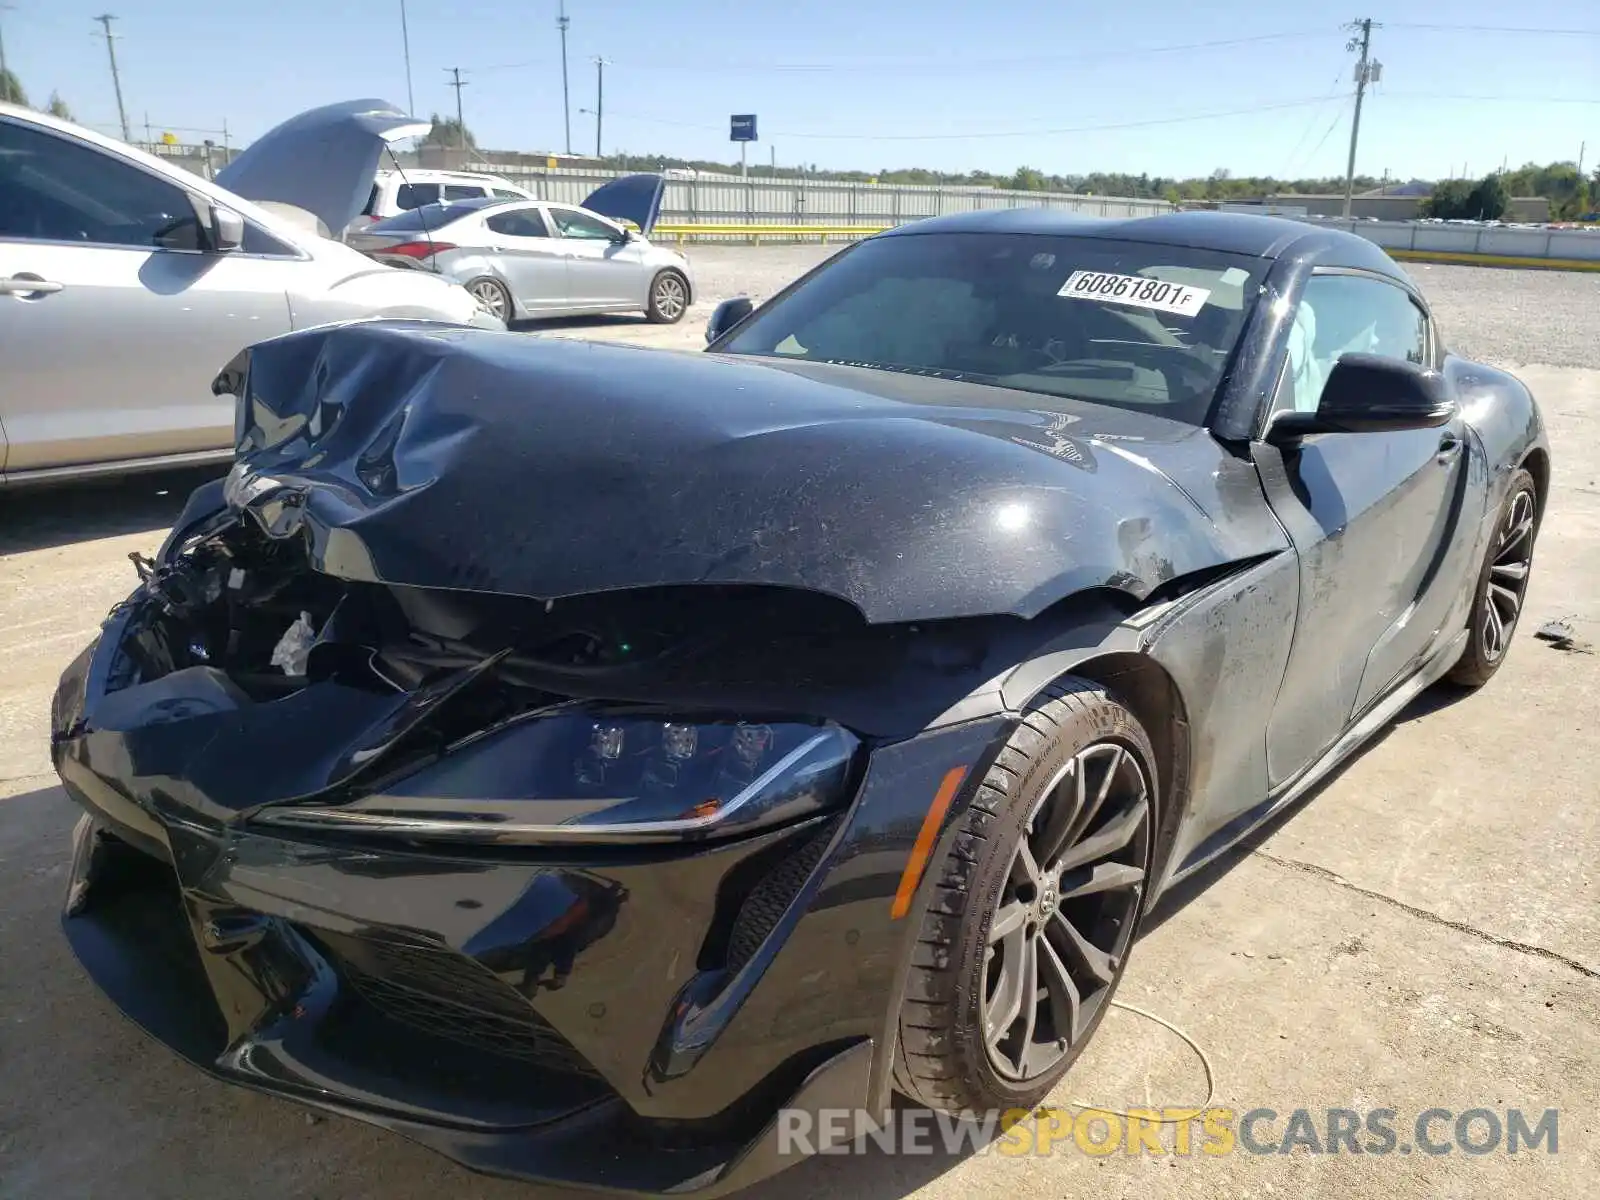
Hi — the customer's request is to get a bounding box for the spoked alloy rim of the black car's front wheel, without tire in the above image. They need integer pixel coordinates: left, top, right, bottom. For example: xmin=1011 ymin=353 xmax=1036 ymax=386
xmin=981 ymin=741 xmax=1150 ymax=1082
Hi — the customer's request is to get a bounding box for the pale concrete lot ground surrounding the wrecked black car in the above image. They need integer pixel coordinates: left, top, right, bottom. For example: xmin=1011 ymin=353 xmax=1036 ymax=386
xmin=0 ymin=248 xmax=1600 ymax=1200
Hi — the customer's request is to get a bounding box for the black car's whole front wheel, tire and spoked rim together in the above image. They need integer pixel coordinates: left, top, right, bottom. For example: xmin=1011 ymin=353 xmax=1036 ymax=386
xmin=894 ymin=677 xmax=1155 ymax=1112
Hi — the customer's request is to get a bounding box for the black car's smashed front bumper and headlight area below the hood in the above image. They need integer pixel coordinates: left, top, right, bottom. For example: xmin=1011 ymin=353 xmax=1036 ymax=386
xmin=53 ymin=454 xmax=1022 ymax=1194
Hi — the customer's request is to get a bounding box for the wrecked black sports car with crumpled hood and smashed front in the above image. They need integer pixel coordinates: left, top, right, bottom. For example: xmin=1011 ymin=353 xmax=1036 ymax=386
xmin=53 ymin=210 xmax=1549 ymax=1194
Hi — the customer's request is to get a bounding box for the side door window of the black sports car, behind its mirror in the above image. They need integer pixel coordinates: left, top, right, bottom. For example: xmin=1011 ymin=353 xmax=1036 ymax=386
xmin=1277 ymin=275 xmax=1427 ymax=413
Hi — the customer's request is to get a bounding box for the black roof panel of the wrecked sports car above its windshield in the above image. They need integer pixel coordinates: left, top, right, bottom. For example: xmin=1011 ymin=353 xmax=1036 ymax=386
xmin=878 ymin=208 xmax=1406 ymax=280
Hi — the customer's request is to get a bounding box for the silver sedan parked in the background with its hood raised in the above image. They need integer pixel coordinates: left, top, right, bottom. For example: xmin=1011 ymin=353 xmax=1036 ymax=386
xmin=347 ymin=200 xmax=694 ymax=325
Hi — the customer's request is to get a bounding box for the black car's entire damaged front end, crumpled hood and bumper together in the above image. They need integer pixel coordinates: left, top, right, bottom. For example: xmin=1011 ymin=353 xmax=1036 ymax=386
xmin=53 ymin=322 xmax=1259 ymax=1194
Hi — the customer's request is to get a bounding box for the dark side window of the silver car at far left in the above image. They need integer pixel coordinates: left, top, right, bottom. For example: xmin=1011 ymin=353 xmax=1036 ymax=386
xmin=0 ymin=120 xmax=203 ymax=250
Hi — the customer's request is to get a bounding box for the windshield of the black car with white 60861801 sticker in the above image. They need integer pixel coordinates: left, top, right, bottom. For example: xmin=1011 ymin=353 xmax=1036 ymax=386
xmin=717 ymin=234 xmax=1267 ymax=424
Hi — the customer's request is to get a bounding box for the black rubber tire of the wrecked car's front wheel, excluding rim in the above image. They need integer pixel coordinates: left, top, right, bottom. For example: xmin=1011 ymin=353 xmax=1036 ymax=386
xmin=894 ymin=677 xmax=1157 ymax=1112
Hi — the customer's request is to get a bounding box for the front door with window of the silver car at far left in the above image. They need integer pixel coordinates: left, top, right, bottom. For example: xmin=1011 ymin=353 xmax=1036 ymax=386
xmin=0 ymin=117 xmax=294 ymax=475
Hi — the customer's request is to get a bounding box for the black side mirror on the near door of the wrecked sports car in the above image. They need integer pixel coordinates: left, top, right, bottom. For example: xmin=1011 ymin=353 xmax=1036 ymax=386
xmin=1266 ymin=354 xmax=1456 ymax=445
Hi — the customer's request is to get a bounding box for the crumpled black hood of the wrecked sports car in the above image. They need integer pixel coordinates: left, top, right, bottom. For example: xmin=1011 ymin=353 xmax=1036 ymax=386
xmin=219 ymin=322 xmax=1275 ymax=622
